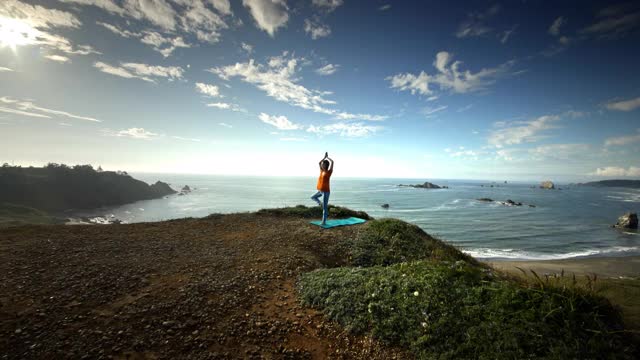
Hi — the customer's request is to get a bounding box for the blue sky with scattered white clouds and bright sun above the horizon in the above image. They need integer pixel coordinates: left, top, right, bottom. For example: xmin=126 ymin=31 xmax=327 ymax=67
xmin=0 ymin=0 xmax=640 ymax=181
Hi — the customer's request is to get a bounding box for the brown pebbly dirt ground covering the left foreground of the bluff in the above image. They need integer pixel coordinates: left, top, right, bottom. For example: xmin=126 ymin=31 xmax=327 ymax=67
xmin=0 ymin=214 xmax=409 ymax=359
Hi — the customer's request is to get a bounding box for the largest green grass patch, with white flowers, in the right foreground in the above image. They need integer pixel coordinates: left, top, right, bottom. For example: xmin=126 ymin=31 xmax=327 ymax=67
xmin=298 ymin=260 xmax=637 ymax=359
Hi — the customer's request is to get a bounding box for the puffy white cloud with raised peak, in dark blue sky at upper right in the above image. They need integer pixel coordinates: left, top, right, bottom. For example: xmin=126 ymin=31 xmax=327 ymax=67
xmin=386 ymin=51 xmax=514 ymax=95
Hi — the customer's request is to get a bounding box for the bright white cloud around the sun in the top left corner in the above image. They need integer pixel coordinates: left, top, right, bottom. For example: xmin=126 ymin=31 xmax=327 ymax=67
xmin=0 ymin=0 xmax=98 ymax=55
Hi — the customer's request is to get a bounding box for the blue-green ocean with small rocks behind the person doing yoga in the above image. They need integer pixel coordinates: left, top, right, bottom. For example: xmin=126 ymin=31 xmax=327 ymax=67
xmin=72 ymin=174 xmax=640 ymax=260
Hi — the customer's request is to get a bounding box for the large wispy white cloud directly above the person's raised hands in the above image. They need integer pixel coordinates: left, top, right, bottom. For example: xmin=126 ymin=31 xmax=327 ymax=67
xmin=208 ymin=52 xmax=386 ymax=120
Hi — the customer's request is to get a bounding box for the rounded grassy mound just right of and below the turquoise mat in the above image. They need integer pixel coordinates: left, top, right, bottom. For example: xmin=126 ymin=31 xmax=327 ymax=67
xmin=346 ymin=219 xmax=477 ymax=266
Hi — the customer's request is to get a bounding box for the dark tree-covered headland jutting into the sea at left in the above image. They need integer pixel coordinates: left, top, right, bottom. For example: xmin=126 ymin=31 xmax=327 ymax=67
xmin=0 ymin=164 xmax=176 ymax=213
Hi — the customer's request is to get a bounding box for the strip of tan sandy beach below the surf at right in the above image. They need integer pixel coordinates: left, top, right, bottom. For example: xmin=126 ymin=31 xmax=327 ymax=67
xmin=478 ymin=255 xmax=640 ymax=279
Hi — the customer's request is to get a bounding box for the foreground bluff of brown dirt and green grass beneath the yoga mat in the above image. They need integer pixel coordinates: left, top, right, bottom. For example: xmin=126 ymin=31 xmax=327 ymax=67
xmin=0 ymin=206 xmax=637 ymax=359
